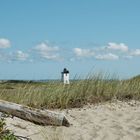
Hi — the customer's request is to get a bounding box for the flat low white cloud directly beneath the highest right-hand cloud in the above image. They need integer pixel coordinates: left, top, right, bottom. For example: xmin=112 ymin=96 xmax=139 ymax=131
xmin=95 ymin=53 xmax=119 ymax=60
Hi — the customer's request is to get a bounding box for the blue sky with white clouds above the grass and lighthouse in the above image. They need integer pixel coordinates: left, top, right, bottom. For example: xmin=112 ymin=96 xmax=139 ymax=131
xmin=0 ymin=0 xmax=140 ymax=80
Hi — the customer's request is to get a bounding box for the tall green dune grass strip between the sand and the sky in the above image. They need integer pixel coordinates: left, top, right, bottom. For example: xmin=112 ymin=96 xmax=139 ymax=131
xmin=0 ymin=74 xmax=140 ymax=109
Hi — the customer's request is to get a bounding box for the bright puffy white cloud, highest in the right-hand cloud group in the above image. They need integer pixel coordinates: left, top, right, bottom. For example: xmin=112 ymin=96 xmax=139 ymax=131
xmin=106 ymin=42 xmax=128 ymax=52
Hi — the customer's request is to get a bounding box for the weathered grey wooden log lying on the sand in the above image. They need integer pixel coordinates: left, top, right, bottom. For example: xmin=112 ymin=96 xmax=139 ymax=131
xmin=0 ymin=100 xmax=69 ymax=126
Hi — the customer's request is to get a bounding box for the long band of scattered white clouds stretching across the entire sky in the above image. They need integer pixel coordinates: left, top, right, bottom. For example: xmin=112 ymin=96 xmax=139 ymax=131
xmin=0 ymin=38 xmax=140 ymax=62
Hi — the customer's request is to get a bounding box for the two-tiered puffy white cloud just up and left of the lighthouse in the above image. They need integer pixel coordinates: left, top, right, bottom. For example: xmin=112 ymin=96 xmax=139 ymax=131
xmin=35 ymin=43 xmax=60 ymax=60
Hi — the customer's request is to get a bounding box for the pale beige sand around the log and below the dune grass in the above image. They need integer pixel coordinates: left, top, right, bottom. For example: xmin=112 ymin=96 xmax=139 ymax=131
xmin=3 ymin=101 xmax=140 ymax=140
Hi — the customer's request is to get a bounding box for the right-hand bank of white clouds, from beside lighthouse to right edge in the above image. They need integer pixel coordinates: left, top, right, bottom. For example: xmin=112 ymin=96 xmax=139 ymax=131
xmin=71 ymin=42 xmax=140 ymax=61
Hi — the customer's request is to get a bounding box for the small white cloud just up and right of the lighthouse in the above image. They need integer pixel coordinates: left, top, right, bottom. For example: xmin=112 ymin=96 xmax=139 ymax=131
xmin=73 ymin=48 xmax=95 ymax=57
